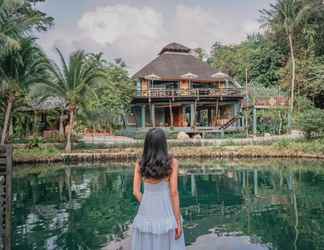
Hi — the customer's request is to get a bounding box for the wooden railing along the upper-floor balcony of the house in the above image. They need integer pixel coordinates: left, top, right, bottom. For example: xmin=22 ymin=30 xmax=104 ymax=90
xmin=136 ymin=88 xmax=243 ymax=98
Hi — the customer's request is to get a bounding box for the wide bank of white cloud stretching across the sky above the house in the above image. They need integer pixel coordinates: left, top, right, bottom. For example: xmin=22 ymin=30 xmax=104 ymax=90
xmin=41 ymin=4 xmax=266 ymax=73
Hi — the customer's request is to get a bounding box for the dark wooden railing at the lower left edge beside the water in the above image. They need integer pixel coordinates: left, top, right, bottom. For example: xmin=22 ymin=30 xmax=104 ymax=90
xmin=0 ymin=145 xmax=12 ymax=250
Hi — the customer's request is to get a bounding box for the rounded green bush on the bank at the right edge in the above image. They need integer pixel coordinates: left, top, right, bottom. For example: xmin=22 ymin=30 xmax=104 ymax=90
xmin=297 ymin=108 xmax=324 ymax=139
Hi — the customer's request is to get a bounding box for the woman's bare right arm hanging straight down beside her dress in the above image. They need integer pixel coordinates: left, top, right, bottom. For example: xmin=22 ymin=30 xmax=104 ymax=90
xmin=170 ymin=159 xmax=182 ymax=238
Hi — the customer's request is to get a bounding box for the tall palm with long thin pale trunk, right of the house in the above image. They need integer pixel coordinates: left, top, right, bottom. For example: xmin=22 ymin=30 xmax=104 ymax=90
xmin=261 ymin=0 xmax=312 ymax=129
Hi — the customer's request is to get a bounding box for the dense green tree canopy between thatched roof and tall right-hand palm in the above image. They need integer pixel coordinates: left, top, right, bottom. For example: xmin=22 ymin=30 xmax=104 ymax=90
xmin=208 ymin=34 xmax=284 ymax=87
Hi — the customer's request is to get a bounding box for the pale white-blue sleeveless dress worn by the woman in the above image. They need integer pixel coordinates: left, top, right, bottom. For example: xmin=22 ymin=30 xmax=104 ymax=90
xmin=132 ymin=180 xmax=185 ymax=250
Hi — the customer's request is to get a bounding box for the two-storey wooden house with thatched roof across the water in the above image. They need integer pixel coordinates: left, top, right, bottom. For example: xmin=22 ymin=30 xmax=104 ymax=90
xmin=129 ymin=43 xmax=243 ymax=132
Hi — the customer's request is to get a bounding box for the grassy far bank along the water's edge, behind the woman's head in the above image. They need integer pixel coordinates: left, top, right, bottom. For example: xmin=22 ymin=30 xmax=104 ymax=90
xmin=14 ymin=137 xmax=324 ymax=164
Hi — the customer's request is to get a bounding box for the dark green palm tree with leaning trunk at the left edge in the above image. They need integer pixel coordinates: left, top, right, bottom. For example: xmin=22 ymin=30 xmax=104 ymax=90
xmin=0 ymin=39 xmax=47 ymax=144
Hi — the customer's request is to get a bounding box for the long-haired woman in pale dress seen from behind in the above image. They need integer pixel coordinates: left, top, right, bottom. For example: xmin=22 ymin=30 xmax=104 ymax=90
xmin=132 ymin=128 xmax=185 ymax=250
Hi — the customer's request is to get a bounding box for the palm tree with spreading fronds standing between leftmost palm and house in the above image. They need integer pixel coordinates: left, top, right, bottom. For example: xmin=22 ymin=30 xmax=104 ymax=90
xmin=36 ymin=49 xmax=105 ymax=152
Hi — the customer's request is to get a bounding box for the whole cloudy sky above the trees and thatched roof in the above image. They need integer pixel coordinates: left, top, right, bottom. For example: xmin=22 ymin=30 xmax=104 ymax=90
xmin=38 ymin=0 xmax=271 ymax=73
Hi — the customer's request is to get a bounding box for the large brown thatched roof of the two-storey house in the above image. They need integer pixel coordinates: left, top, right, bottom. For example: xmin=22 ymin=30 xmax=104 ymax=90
xmin=133 ymin=43 xmax=237 ymax=82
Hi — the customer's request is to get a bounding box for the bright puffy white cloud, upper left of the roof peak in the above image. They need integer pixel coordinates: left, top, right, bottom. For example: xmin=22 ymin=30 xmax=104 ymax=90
xmin=78 ymin=4 xmax=163 ymax=44
